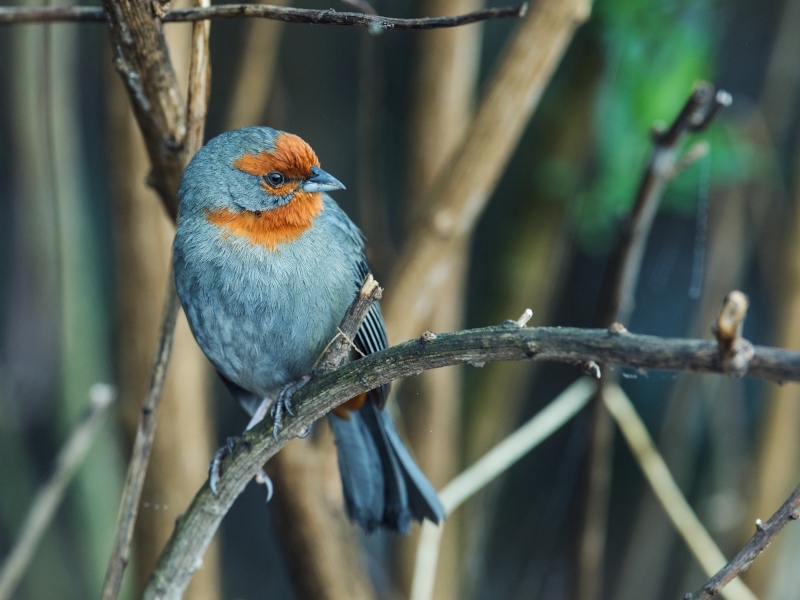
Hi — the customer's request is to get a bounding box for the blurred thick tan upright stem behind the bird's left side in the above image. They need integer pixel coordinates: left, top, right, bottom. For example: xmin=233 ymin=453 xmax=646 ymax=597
xmin=109 ymin=58 xmax=220 ymax=600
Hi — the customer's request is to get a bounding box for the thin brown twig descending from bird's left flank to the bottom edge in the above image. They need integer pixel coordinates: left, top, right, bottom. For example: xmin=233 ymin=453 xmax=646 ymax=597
xmin=101 ymin=280 xmax=180 ymax=600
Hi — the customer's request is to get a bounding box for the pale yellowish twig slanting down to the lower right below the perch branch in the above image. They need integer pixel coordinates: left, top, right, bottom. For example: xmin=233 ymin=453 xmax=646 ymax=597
xmin=603 ymin=384 xmax=757 ymax=600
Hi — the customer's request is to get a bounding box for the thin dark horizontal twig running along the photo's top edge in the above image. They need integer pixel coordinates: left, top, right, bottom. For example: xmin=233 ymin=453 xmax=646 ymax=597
xmin=0 ymin=3 xmax=527 ymax=26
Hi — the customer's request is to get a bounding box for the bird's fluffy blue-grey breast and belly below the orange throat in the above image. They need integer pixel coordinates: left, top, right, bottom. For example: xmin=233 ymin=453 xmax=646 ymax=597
xmin=175 ymin=209 xmax=357 ymax=396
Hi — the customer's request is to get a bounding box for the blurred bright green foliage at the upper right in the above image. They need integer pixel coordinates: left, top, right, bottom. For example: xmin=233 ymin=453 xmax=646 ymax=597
xmin=536 ymin=0 xmax=764 ymax=253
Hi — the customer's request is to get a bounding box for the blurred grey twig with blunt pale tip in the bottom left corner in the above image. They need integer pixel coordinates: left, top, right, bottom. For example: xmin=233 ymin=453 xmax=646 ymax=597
xmin=0 ymin=383 xmax=117 ymax=600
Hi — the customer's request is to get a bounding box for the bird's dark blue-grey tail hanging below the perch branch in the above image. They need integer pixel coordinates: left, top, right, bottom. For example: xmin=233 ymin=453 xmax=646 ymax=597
xmin=328 ymin=401 xmax=444 ymax=533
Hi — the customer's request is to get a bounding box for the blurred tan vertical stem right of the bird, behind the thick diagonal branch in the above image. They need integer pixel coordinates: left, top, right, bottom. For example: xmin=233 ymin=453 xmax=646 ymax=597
xmin=397 ymin=0 xmax=483 ymax=599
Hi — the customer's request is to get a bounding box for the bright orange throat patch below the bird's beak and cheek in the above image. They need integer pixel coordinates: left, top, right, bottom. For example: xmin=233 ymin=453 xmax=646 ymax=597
xmin=206 ymin=192 xmax=322 ymax=250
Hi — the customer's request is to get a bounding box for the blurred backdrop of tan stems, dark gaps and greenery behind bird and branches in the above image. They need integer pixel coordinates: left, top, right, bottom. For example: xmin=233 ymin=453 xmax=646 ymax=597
xmin=0 ymin=0 xmax=800 ymax=600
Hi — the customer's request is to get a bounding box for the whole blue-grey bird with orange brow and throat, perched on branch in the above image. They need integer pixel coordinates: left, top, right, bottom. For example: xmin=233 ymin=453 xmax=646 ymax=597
xmin=173 ymin=127 xmax=445 ymax=533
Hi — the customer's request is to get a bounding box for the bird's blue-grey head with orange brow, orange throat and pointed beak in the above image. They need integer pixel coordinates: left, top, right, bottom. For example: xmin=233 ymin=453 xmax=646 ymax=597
xmin=179 ymin=127 xmax=344 ymax=248
